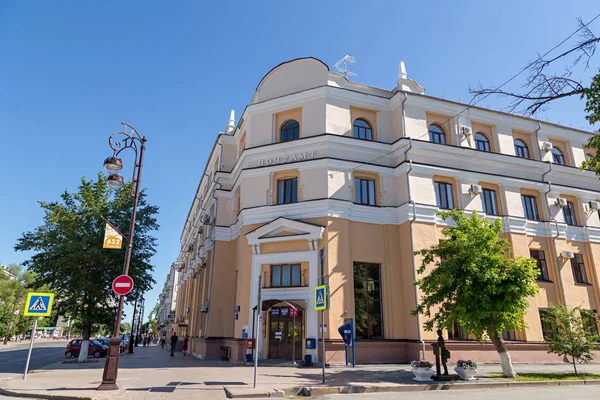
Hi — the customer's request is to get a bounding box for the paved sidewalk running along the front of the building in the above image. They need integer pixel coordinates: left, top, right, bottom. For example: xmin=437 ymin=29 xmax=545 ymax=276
xmin=0 ymin=346 xmax=600 ymax=400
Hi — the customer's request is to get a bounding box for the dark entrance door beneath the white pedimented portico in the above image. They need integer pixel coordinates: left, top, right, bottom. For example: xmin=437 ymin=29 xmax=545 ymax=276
xmin=269 ymin=306 xmax=304 ymax=361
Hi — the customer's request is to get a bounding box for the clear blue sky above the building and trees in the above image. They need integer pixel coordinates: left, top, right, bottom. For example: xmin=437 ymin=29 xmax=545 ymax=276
xmin=0 ymin=0 xmax=600 ymax=324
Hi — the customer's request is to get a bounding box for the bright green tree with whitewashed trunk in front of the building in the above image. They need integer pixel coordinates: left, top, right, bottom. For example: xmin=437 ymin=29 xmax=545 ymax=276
xmin=413 ymin=210 xmax=539 ymax=377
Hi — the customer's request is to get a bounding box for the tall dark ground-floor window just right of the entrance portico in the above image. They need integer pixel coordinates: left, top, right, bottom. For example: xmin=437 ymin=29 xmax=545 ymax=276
xmin=354 ymin=262 xmax=383 ymax=339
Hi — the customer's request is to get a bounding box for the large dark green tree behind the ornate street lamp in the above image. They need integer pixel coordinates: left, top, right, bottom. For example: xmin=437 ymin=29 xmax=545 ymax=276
xmin=15 ymin=173 xmax=158 ymax=361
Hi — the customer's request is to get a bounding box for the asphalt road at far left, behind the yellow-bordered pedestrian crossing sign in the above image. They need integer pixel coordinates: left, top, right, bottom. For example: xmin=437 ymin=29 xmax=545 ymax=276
xmin=0 ymin=339 xmax=68 ymax=379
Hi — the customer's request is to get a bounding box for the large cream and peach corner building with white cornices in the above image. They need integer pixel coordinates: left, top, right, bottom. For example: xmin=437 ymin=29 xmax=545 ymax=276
xmin=168 ymin=58 xmax=600 ymax=363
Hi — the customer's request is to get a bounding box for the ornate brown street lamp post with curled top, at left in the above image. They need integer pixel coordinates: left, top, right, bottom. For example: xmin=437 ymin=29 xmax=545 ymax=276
xmin=98 ymin=122 xmax=146 ymax=390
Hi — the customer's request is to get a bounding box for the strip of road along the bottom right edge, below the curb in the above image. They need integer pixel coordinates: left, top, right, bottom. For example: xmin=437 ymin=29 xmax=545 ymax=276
xmin=319 ymin=385 xmax=600 ymax=400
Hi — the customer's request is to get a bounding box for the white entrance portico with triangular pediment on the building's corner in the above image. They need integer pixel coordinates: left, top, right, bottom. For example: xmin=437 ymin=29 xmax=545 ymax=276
xmin=246 ymin=218 xmax=325 ymax=361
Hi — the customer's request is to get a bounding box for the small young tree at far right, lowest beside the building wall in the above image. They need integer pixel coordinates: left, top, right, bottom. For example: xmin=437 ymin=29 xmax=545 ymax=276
xmin=542 ymin=304 xmax=600 ymax=375
